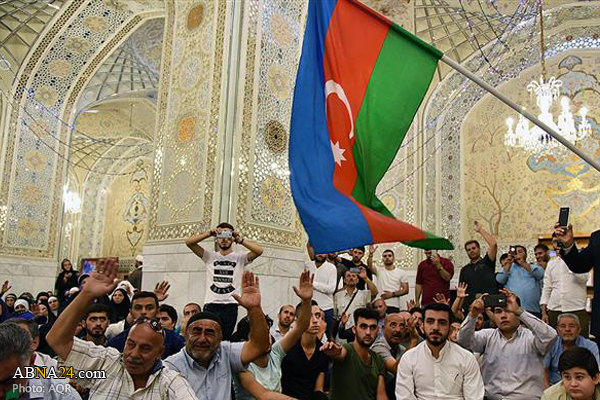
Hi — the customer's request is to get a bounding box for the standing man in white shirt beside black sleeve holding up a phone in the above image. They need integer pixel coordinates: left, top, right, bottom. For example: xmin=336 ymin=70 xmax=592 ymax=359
xmin=540 ymin=235 xmax=590 ymax=337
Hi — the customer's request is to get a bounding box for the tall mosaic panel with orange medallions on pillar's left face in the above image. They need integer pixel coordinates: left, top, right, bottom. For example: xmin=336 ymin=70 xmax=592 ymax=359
xmin=148 ymin=1 xmax=232 ymax=242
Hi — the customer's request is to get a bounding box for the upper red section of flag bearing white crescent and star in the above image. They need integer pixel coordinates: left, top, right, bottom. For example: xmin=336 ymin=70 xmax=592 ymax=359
xmin=323 ymin=0 xmax=390 ymax=196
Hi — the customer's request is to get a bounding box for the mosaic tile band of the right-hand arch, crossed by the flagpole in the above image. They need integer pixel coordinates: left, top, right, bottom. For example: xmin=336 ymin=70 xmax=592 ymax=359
xmin=425 ymin=3 xmax=600 ymax=265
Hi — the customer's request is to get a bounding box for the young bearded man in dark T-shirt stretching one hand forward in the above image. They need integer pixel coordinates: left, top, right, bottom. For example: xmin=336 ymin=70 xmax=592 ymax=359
xmin=321 ymin=308 xmax=388 ymax=400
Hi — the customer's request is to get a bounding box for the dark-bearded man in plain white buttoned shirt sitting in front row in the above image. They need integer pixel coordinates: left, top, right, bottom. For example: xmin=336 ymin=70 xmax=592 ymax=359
xmin=396 ymin=303 xmax=484 ymax=400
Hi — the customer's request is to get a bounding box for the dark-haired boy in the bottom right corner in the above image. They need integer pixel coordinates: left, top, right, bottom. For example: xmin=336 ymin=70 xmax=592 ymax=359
xmin=542 ymin=346 xmax=600 ymax=400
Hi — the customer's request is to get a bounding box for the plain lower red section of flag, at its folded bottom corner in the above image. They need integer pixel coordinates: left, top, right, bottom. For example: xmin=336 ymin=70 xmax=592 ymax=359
xmin=352 ymin=199 xmax=425 ymax=243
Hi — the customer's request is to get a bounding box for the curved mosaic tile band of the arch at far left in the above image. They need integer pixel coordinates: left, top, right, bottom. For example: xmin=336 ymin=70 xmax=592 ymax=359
xmin=0 ymin=0 xmax=162 ymax=257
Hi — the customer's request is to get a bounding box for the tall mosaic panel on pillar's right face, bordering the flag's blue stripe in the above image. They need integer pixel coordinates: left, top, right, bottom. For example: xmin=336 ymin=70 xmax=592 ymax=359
xmin=232 ymin=0 xmax=306 ymax=248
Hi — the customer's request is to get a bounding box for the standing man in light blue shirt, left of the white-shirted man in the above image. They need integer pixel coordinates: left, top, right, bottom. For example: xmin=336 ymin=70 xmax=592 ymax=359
xmin=496 ymin=246 xmax=544 ymax=318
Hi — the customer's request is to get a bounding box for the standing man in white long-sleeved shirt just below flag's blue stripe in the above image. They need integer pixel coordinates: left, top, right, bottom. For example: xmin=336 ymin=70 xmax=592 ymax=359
xmin=305 ymin=246 xmax=337 ymax=338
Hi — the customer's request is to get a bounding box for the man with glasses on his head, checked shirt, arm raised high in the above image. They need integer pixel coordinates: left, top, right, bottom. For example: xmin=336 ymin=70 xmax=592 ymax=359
xmin=46 ymin=259 xmax=197 ymax=400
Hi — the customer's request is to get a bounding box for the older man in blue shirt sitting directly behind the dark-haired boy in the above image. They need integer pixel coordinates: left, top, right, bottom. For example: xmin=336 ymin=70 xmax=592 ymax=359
xmin=544 ymin=313 xmax=600 ymax=385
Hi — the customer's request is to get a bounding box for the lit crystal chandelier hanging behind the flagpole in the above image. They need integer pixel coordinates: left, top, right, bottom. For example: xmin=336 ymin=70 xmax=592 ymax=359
xmin=504 ymin=2 xmax=592 ymax=154
